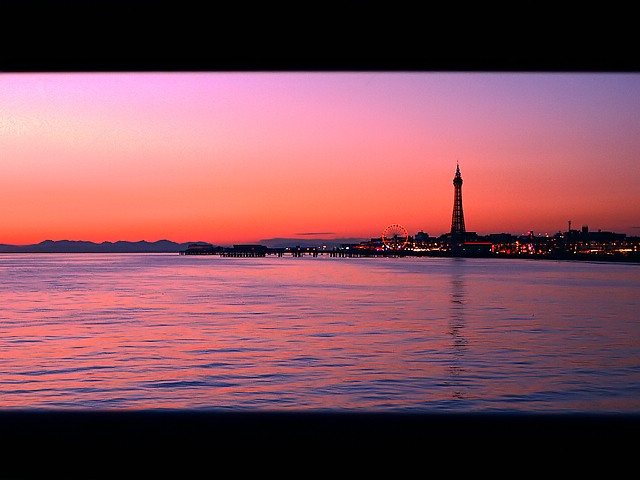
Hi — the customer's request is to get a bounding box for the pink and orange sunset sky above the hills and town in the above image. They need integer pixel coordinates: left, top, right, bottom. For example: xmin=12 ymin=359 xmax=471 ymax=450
xmin=0 ymin=71 xmax=640 ymax=245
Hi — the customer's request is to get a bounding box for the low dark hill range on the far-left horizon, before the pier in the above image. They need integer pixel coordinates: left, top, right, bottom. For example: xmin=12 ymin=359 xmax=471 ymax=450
xmin=0 ymin=240 xmax=198 ymax=253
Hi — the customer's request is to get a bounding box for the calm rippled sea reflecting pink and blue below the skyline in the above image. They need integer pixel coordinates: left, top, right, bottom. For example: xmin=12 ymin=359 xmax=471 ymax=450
xmin=0 ymin=254 xmax=640 ymax=414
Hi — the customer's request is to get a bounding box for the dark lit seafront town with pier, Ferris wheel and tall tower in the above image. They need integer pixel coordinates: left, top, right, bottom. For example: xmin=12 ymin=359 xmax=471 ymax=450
xmin=180 ymin=164 xmax=640 ymax=261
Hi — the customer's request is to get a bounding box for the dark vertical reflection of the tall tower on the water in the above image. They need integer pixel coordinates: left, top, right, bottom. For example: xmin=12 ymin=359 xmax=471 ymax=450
xmin=447 ymin=258 xmax=467 ymax=399
